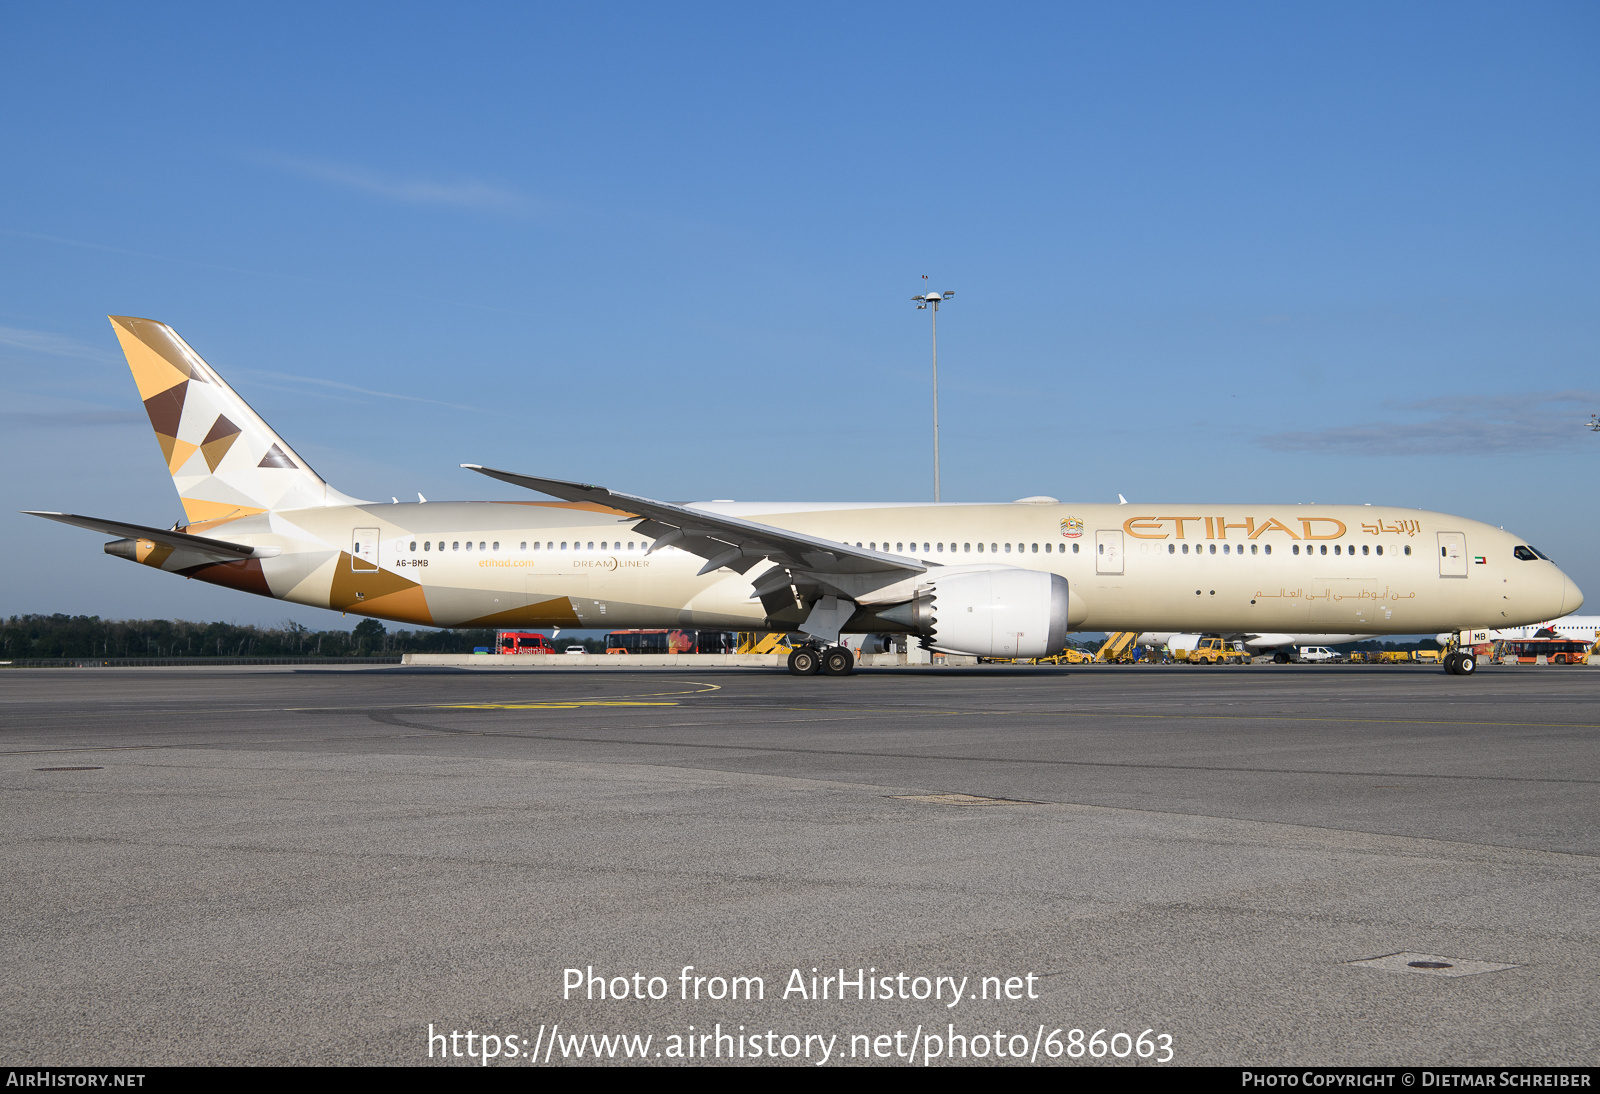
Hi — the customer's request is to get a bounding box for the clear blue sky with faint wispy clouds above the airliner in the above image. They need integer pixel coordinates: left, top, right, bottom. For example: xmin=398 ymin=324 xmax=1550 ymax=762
xmin=0 ymin=3 xmax=1600 ymax=627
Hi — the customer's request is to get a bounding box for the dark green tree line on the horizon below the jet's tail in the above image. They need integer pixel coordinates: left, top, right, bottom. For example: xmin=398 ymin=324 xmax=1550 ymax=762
xmin=0 ymin=614 xmax=494 ymax=661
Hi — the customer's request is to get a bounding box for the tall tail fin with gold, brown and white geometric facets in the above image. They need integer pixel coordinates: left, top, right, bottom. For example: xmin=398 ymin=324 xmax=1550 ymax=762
xmin=110 ymin=315 xmax=355 ymax=525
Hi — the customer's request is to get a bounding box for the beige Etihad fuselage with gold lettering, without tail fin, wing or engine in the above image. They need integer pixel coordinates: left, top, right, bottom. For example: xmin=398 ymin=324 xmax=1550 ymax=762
xmin=139 ymin=502 xmax=1581 ymax=633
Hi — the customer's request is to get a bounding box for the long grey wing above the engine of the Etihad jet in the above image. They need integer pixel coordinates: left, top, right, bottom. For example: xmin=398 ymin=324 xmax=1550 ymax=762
xmin=462 ymin=464 xmax=928 ymax=597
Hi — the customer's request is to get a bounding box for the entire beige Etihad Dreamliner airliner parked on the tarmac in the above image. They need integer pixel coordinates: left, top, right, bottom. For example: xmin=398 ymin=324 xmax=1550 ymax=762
xmin=35 ymin=315 xmax=1582 ymax=675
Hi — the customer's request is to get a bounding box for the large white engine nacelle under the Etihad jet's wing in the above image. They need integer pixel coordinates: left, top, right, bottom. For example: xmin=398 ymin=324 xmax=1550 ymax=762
xmin=880 ymin=569 xmax=1070 ymax=657
